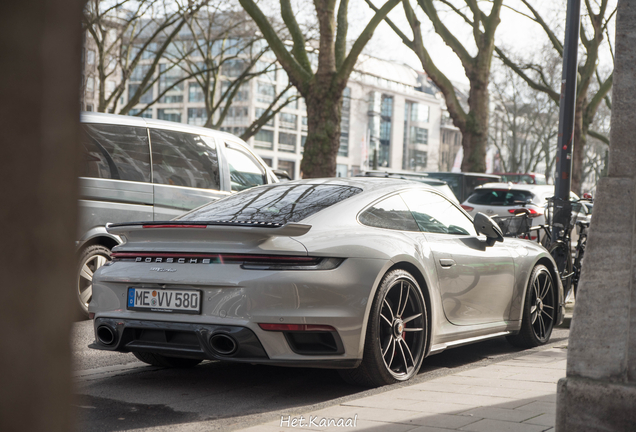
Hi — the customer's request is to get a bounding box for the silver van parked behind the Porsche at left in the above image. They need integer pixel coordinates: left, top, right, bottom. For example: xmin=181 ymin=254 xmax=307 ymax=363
xmin=76 ymin=113 xmax=278 ymax=314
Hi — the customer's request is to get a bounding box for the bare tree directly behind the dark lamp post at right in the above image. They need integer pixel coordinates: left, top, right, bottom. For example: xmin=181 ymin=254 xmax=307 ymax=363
xmin=495 ymin=0 xmax=616 ymax=193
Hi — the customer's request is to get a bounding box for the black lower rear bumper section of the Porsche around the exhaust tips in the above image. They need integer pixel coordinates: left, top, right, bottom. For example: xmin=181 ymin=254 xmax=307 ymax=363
xmin=89 ymin=317 xmax=360 ymax=369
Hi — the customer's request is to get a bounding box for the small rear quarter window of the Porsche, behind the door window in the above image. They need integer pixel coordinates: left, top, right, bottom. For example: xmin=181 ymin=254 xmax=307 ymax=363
xmin=359 ymin=195 xmax=419 ymax=231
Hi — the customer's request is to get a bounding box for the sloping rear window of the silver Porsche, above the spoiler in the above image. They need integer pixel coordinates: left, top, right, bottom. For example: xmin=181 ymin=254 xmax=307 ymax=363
xmin=177 ymin=183 xmax=362 ymax=224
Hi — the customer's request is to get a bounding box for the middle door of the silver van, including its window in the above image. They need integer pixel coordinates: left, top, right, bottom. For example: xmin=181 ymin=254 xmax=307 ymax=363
xmin=150 ymin=128 xmax=229 ymax=220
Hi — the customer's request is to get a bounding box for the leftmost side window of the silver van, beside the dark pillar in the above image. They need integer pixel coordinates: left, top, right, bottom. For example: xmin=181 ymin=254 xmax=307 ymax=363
xmin=80 ymin=124 xmax=150 ymax=182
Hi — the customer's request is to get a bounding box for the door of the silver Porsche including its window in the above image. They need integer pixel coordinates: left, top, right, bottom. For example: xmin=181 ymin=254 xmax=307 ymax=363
xmin=402 ymin=190 xmax=514 ymax=325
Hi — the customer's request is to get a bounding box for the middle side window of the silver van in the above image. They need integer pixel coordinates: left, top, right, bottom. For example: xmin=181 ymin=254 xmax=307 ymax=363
xmin=150 ymin=129 xmax=220 ymax=190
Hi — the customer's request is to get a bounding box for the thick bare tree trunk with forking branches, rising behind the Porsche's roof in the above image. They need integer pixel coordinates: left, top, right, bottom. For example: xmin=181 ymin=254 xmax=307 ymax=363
xmin=239 ymin=0 xmax=400 ymax=178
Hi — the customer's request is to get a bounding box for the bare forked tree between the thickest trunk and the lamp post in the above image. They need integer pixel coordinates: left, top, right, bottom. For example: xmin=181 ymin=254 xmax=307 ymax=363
xmin=366 ymin=0 xmax=503 ymax=172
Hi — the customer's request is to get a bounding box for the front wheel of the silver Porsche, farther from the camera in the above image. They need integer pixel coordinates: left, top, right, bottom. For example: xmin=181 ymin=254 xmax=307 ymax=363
xmin=507 ymin=264 xmax=558 ymax=348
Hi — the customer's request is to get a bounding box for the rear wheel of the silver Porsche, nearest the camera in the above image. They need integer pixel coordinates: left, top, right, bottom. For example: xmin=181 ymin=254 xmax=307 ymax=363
xmin=338 ymin=270 xmax=428 ymax=387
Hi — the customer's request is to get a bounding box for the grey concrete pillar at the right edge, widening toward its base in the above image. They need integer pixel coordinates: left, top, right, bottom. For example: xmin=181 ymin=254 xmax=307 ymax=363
xmin=556 ymin=0 xmax=636 ymax=432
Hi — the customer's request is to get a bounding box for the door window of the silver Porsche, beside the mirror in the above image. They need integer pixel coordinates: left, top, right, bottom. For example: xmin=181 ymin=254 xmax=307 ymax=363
xmin=402 ymin=191 xmax=477 ymax=236
